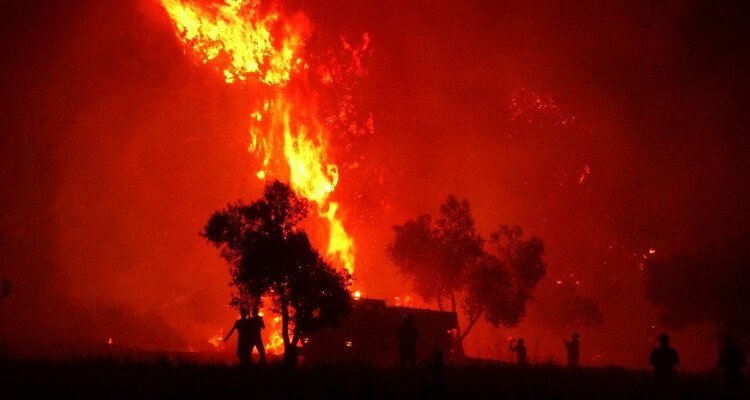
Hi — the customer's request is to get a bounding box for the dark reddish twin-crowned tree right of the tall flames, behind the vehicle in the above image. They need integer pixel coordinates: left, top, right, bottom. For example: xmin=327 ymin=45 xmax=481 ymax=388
xmin=388 ymin=195 xmax=546 ymax=355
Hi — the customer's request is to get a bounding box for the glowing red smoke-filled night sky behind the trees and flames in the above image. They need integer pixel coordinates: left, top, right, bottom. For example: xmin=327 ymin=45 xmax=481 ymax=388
xmin=0 ymin=0 xmax=750 ymax=369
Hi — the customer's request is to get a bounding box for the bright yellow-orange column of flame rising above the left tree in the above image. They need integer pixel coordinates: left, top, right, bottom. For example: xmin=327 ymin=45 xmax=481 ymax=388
xmin=161 ymin=0 xmax=354 ymax=273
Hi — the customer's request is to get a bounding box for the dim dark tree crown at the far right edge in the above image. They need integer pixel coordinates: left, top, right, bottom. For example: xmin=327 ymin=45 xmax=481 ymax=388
xmin=644 ymin=235 xmax=750 ymax=339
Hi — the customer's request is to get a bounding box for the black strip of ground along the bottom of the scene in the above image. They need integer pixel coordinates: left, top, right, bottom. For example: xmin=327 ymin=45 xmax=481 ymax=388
xmin=0 ymin=359 xmax=750 ymax=399
